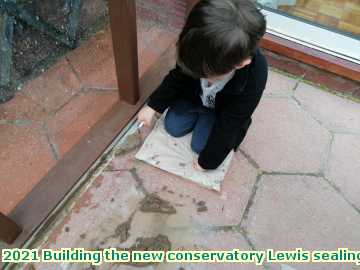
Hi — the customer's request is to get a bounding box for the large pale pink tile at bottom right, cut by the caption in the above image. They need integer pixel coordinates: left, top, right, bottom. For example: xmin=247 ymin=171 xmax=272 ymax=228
xmin=244 ymin=175 xmax=360 ymax=270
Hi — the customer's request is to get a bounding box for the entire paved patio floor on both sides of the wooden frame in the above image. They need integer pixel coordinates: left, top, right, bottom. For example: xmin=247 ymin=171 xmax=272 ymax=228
xmin=0 ymin=0 xmax=360 ymax=270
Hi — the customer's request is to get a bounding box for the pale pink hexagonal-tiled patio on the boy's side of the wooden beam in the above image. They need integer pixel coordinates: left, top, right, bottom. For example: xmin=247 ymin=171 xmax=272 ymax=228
xmin=16 ymin=65 xmax=360 ymax=270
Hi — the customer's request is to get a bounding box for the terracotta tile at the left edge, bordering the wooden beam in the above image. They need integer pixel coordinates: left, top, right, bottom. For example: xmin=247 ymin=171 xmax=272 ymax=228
xmin=0 ymin=125 xmax=55 ymax=214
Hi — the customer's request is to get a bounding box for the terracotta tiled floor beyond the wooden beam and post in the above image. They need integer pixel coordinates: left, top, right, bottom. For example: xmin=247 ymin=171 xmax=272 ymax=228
xmin=0 ymin=0 xmax=185 ymax=214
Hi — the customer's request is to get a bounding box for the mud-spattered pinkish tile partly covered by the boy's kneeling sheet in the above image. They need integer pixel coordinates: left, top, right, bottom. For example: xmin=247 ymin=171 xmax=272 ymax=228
xmin=133 ymin=151 xmax=257 ymax=228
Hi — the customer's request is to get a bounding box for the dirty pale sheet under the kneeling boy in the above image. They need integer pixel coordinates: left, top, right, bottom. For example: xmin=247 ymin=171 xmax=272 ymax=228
xmin=135 ymin=117 xmax=233 ymax=192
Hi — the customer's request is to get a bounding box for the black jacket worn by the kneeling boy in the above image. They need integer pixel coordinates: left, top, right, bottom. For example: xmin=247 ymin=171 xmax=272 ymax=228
xmin=148 ymin=49 xmax=268 ymax=170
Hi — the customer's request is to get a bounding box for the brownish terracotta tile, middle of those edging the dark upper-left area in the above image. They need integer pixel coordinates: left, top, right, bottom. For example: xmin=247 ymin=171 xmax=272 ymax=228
xmin=22 ymin=59 xmax=80 ymax=112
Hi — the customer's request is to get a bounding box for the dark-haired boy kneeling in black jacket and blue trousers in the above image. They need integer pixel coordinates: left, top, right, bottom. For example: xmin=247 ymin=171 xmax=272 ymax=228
xmin=138 ymin=0 xmax=268 ymax=170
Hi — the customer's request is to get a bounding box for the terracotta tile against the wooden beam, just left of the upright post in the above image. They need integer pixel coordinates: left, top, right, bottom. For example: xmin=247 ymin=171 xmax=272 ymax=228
xmin=48 ymin=90 xmax=119 ymax=157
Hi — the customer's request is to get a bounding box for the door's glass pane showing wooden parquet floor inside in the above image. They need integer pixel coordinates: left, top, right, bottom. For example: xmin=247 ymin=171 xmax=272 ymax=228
xmin=257 ymin=0 xmax=360 ymax=38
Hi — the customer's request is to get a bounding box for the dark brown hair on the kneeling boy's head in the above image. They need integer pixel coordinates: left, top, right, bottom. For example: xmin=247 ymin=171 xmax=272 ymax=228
xmin=177 ymin=0 xmax=266 ymax=78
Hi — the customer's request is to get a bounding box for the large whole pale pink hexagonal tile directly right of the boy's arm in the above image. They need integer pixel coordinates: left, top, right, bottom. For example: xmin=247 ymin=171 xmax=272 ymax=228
xmin=241 ymin=98 xmax=331 ymax=173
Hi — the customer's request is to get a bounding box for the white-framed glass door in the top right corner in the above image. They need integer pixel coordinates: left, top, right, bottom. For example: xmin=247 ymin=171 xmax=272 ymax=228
xmin=257 ymin=0 xmax=360 ymax=64
